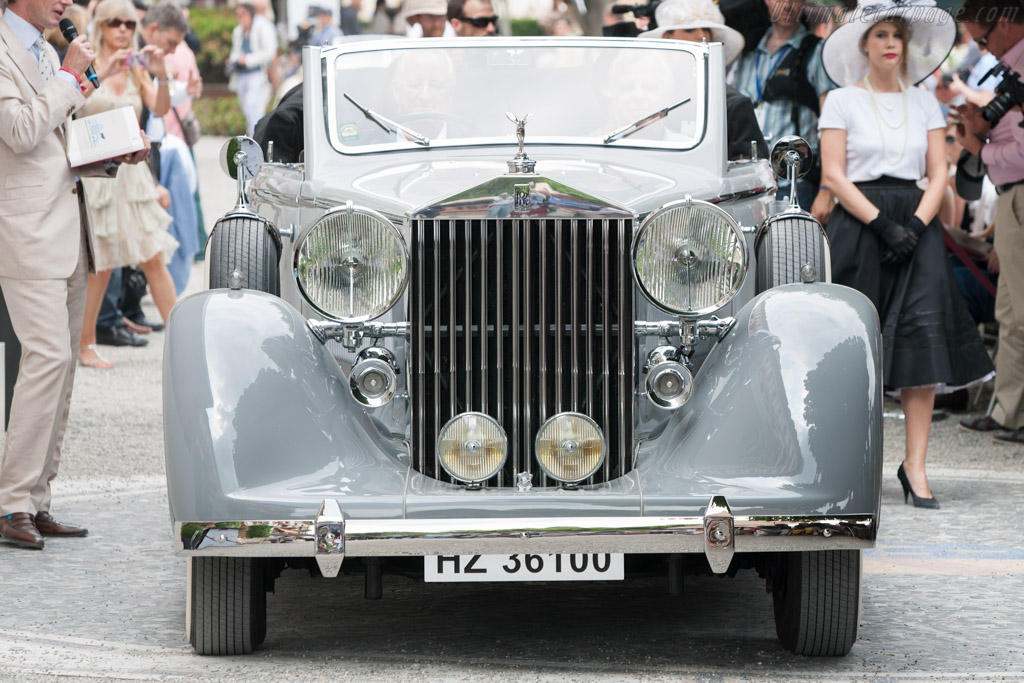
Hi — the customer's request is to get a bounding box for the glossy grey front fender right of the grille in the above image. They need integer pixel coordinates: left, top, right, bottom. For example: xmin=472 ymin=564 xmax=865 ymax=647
xmin=637 ymin=284 xmax=882 ymax=515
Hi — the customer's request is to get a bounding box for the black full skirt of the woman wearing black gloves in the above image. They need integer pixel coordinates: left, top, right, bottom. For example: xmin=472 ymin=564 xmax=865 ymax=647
xmin=826 ymin=176 xmax=992 ymax=389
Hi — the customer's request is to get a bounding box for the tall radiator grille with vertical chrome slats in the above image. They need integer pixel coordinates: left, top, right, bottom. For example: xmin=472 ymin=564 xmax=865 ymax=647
xmin=410 ymin=218 xmax=634 ymax=486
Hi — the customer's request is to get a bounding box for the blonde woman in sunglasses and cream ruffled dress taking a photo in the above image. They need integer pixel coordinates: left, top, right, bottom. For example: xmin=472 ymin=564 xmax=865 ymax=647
xmin=79 ymin=0 xmax=177 ymax=368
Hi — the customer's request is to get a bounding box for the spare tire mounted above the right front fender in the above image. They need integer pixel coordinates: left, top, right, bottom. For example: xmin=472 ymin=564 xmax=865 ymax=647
xmin=755 ymin=215 xmax=831 ymax=294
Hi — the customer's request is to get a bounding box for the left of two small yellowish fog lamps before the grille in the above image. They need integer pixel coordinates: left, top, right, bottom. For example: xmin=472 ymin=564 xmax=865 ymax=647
xmin=437 ymin=413 xmax=508 ymax=483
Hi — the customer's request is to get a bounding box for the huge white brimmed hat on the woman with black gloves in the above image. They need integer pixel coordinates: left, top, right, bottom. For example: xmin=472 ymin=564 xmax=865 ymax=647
xmin=821 ymin=0 xmax=956 ymax=87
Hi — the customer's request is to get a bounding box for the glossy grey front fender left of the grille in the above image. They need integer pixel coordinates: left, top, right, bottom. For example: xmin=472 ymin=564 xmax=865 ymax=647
xmin=164 ymin=290 xmax=408 ymax=520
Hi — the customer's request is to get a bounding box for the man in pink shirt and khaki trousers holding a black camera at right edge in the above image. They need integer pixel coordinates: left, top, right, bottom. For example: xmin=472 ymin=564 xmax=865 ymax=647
xmin=956 ymin=0 xmax=1024 ymax=443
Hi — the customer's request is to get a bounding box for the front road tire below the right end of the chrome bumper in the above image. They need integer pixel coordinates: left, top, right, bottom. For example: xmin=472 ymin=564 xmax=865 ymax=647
xmin=772 ymin=550 xmax=862 ymax=656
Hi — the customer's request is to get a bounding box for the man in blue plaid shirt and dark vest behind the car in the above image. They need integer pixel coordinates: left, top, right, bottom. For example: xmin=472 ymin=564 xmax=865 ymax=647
xmin=731 ymin=0 xmax=836 ymax=215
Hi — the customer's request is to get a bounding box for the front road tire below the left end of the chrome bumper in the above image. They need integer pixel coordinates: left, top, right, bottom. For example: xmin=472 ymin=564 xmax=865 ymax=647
xmin=191 ymin=557 xmax=266 ymax=655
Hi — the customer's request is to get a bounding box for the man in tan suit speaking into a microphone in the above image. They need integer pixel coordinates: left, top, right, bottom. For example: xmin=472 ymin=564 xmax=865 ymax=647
xmin=0 ymin=0 xmax=148 ymax=548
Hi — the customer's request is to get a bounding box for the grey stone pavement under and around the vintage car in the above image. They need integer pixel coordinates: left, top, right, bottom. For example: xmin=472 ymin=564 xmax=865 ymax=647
xmin=0 ymin=139 xmax=1024 ymax=682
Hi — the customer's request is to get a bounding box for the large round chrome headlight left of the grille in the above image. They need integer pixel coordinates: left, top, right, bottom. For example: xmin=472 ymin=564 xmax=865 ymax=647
xmin=295 ymin=206 xmax=409 ymax=323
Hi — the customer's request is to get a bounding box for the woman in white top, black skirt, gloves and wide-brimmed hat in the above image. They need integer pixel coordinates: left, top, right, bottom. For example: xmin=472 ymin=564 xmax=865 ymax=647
xmin=818 ymin=1 xmax=992 ymax=508
